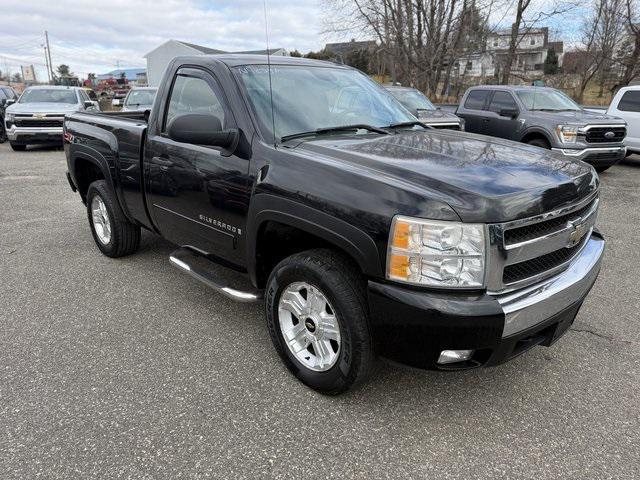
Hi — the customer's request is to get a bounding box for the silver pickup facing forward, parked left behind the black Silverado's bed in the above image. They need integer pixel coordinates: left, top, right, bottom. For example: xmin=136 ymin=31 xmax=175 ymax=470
xmin=4 ymin=86 xmax=98 ymax=151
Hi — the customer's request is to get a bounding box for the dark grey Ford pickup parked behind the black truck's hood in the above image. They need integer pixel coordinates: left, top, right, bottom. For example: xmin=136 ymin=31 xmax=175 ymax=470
xmin=456 ymin=85 xmax=627 ymax=172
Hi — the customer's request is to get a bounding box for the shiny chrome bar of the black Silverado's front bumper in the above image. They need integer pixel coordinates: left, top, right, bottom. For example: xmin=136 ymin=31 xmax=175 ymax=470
xmin=496 ymin=235 xmax=605 ymax=338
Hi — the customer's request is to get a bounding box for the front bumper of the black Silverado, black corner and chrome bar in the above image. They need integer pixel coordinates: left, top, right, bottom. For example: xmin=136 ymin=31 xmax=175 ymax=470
xmin=369 ymin=233 xmax=605 ymax=370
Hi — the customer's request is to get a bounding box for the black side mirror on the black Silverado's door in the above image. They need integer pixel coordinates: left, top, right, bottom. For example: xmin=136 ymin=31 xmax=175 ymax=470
xmin=167 ymin=113 xmax=239 ymax=150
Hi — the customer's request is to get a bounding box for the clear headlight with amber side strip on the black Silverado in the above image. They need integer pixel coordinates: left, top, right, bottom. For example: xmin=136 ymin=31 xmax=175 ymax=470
xmin=387 ymin=216 xmax=486 ymax=288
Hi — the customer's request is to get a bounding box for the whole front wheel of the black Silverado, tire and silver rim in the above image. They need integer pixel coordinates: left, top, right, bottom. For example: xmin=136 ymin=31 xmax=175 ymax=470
xmin=265 ymin=249 xmax=373 ymax=395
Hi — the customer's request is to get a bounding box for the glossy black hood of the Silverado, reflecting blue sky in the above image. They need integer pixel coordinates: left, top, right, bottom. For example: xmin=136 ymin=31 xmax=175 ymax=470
xmin=297 ymin=130 xmax=598 ymax=223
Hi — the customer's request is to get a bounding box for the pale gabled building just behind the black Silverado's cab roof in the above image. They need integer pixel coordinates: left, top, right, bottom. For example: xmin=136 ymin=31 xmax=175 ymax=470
xmin=144 ymin=40 xmax=289 ymax=87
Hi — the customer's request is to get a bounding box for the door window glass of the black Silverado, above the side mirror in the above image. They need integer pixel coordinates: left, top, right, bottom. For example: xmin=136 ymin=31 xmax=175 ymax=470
xmin=162 ymin=75 xmax=225 ymax=132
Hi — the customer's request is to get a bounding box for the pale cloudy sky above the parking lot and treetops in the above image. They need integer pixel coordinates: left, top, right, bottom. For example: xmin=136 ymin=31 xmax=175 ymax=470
xmin=0 ymin=0 xmax=578 ymax=81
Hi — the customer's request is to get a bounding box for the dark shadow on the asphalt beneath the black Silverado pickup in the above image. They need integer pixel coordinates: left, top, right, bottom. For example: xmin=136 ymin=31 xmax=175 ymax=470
xmin=130 ymin=232 xmax=548 ymax=406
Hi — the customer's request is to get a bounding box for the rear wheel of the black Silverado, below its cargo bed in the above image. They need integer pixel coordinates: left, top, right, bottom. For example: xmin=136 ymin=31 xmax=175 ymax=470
xmin=87 ymin=180 xmax=140 ymax=258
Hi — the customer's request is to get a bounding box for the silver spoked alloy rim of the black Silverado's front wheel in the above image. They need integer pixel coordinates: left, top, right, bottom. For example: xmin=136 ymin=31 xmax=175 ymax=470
xmin=278 ymin=282 xmax=341 ymax=372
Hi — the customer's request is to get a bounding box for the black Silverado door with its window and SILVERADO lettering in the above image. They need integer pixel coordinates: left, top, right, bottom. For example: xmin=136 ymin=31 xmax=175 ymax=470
xmin=147 ymin=68 xmax=249 ymax=261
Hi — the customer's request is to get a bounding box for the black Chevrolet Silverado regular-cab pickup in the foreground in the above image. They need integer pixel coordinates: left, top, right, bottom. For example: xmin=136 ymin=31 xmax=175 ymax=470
xmin=64 ymin=55 xmax=604 ymax=394
